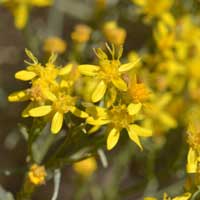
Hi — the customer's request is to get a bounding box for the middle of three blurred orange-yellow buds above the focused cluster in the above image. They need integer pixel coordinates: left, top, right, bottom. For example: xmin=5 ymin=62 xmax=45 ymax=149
xmin=71 ymin=24 xmax=92 ymax=43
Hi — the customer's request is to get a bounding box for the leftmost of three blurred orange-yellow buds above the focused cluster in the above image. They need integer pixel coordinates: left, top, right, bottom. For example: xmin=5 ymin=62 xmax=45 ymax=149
xmin=43 ymin=37 xmax=67 ymax=54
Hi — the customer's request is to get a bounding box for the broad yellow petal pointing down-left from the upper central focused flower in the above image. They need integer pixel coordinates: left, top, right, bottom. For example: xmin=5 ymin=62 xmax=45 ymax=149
xmin=92 ymin=81 xmax=107 ymax=102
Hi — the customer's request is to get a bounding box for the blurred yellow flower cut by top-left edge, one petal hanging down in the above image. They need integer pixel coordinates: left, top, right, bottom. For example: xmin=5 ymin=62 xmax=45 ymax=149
xmin=3 ymin=0 xmax=53 ymax=29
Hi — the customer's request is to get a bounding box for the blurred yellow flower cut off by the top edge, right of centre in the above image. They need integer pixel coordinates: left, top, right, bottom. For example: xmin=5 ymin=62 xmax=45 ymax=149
xmin=132 ymin=0 xmax=173 ymax=22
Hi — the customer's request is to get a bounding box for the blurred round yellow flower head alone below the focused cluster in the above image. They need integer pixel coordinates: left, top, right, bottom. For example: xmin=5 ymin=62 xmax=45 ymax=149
xmin=73 ymin=157 xmax=97 ymax=177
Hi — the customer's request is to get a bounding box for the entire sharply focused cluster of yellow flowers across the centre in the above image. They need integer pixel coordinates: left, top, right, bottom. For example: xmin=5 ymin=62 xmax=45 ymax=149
xmin=8 ymin=45 xmax=152 ymax=150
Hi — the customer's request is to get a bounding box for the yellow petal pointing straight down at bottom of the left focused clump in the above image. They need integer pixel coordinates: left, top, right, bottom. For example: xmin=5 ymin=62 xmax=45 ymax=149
xmin=51 ymin=112 xmax=63 ymax=134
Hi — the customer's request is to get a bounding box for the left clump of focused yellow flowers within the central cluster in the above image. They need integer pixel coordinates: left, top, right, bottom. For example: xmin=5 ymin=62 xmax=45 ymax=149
xmin=8 ymin=50 xmax=87 ymax=134
